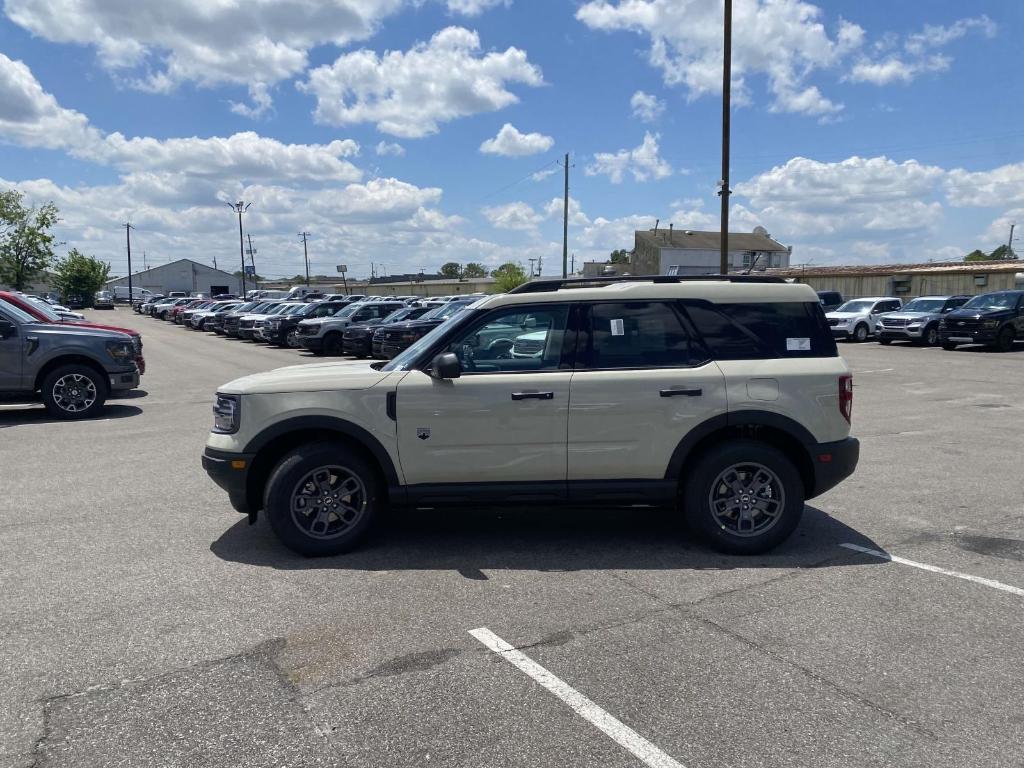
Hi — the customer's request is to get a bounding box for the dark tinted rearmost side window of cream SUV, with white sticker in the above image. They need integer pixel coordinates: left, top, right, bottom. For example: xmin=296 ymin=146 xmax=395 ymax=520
xmin=683 ymin=300 xmax=839 ymax=360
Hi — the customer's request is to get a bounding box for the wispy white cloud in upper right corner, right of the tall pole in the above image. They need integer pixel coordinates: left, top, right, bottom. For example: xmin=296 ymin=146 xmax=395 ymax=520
xmin=846 ymin=15 xmax=996 ymax=85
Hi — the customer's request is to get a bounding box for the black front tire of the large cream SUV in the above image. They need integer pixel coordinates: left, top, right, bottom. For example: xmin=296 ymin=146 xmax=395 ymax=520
xmin=263 ymin=442 xmax=385 ymax=557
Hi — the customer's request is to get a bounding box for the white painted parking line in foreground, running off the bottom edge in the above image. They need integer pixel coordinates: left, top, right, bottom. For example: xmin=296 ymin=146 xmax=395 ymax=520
xmin=469 ymin=627 xmax=684 ymax=768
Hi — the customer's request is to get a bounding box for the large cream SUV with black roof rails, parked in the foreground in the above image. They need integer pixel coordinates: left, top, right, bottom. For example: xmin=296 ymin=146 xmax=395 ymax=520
xmin=203 ymin=276 xmax=859 ymax=556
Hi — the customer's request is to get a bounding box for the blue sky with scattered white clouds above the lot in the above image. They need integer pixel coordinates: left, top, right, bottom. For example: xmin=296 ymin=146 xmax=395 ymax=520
xmin=0 ymin=0 xmax=1024 ymax=275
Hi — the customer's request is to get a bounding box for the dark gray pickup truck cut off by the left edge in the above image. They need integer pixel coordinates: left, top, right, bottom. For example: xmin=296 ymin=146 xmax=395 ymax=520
xmin=0 ymin=300 xmax=138 ymax=419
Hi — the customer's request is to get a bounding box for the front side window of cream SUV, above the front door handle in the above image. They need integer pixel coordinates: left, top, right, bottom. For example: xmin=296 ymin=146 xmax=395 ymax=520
xmin=443 ymin=304 xmax=568 ymax=376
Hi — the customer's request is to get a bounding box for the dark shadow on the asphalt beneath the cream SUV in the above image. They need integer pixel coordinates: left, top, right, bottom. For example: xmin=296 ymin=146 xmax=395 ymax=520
xmin=210 ymin=507 xmax=884 ymax=580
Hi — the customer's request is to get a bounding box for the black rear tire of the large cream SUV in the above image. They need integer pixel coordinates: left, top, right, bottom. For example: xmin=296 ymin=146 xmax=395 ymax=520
xmin=683 ymin=440 xmax=804 ymax=555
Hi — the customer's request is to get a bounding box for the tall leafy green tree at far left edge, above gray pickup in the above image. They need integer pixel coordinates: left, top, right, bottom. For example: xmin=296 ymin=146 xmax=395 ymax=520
xmin=0 ymin=189 xmax=57 ymax=291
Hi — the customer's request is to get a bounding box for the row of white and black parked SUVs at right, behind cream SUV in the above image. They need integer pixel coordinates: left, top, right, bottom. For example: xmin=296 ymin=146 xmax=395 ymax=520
xmin=818 ymin=291 xmax=1024 ymax=351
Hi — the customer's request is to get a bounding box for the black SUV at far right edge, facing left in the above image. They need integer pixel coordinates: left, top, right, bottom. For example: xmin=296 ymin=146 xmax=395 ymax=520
xmin=939 ymin=291 xmax=1024 ymax=352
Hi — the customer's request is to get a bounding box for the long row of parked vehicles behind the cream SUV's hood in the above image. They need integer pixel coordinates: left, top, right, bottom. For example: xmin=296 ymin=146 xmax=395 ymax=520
xmin=136 ymin=294 xmax=483 ymax=359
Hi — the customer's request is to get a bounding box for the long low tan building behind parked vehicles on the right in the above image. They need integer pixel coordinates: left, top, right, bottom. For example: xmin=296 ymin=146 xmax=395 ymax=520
xmin=768 ymin=261 xmax=1024 ymax=299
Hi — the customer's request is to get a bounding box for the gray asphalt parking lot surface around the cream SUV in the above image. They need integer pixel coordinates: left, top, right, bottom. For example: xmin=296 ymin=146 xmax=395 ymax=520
xmin=0 ymin=308 xmax=1024 ymax=768
